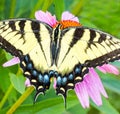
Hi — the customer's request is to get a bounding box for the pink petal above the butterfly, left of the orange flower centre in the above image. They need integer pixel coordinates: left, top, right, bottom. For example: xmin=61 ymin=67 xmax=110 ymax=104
xmin=35 ymin=10 xmax=57 ymax=27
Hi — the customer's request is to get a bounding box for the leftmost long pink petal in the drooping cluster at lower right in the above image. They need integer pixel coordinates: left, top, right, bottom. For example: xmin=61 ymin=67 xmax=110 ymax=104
xmin=75 ymin=81 xmax=89 ymax=108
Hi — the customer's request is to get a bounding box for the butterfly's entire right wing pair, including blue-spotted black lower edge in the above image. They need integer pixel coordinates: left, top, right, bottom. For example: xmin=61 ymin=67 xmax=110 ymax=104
xmin=56 ymin=27 xmax=120 ymax=96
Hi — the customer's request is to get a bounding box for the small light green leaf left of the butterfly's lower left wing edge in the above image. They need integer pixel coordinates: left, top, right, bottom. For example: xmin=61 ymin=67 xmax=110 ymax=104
xmin=9 ymin=73 xmax=25 ymax=94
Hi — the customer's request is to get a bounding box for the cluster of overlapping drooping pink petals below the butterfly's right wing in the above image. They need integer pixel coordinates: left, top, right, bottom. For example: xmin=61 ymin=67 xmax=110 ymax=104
xmin=75 ymin=68 xmax=108 ymax=108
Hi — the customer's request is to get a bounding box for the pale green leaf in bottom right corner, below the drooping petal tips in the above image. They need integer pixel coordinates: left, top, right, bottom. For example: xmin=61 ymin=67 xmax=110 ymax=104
xmin=91 ymin=98 xmax=119 ymax=114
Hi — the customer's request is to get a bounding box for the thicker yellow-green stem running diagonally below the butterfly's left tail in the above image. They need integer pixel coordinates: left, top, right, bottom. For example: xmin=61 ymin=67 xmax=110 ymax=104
xmin=6 ymin=86 xmax=34 ymax=114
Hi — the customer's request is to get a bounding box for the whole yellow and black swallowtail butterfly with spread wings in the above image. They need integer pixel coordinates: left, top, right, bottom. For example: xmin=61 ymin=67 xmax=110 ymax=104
xmin=0 ymin=19 xmax=120 ymax=105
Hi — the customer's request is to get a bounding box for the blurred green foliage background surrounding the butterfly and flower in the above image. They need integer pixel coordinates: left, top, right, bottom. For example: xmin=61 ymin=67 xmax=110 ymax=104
xmin=0 ymin=0 xmax=120 ymax=114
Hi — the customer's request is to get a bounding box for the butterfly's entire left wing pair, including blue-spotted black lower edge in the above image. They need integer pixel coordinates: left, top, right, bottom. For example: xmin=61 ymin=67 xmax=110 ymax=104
xmin=0 ymin=19 xmax=52 ymax=97
